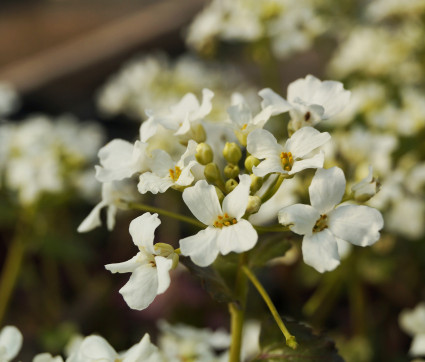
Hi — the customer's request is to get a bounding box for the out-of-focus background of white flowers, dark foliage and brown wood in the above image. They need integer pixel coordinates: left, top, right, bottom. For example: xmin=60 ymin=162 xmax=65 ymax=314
xmin=0 ymin=0 xmax=425 ymax=362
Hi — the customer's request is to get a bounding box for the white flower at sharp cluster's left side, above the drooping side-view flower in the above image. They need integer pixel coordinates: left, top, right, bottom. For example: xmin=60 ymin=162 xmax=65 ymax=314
xmin=96 ymin=139 xmax=149 ymax=182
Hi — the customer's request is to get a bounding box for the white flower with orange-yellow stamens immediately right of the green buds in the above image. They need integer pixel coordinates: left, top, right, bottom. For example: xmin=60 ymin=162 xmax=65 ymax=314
xmin=247 ymin=127 xmax=331 ymax=177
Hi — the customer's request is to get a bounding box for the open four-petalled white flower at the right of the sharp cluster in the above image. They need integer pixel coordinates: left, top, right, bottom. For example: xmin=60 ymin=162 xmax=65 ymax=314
xmin=278 ymin=167 xmax=384 ymax=273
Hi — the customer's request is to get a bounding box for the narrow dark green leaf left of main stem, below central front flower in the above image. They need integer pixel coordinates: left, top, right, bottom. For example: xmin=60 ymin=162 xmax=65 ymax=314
xmin=180 ymin=256 xmax=235 ymax=303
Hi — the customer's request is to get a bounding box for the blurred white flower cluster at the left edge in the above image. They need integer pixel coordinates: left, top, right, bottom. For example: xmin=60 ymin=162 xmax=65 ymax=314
xmin=0 ymin=115 xmax=104 ymax=205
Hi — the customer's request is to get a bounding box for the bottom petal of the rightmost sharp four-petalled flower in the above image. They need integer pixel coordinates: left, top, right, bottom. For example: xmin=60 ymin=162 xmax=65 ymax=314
xmin=302 ymin=229 xmax=339 ymax=273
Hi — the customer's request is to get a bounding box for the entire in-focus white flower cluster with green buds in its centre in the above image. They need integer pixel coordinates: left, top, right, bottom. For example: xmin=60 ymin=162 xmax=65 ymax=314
xmin=79 ymin=75 xmax=383 ymax=310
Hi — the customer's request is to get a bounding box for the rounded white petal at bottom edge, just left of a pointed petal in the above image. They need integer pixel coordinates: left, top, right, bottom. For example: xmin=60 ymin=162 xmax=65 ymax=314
xmin=75 ymin=336 xmax=118 ymax=362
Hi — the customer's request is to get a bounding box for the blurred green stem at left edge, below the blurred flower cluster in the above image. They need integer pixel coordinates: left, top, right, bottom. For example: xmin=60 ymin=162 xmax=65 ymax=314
xmin=0 ymin=236 xmax=25 ymax=325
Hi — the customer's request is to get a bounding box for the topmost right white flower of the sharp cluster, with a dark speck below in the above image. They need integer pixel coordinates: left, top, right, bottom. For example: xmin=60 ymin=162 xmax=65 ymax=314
xmin=258 ymin=75 xmax=350 ymax=130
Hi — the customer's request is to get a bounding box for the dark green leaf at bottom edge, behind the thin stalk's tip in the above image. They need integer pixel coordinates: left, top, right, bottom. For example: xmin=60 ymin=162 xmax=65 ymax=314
xmin=254 ymin=318 xmax=344 ymax=362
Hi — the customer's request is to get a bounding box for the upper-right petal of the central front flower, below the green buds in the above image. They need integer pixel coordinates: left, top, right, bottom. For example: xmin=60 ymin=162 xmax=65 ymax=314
xmin=222 ymin=175 xmax=251 ymax=220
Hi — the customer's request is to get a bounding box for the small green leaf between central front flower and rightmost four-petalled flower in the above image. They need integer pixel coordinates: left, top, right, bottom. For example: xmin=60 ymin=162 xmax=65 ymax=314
xmin=250 ymin=235 xmax=292 ymax=267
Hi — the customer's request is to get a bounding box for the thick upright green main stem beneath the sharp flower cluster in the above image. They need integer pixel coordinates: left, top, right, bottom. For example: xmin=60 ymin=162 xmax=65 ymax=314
xmin=229 ymin=253 xmax=248 ymax=362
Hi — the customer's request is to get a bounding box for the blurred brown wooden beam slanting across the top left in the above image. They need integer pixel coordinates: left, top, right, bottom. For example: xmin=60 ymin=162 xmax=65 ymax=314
xmin=0 ymin=0 xmax=205 ymax=93
